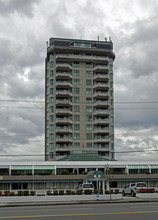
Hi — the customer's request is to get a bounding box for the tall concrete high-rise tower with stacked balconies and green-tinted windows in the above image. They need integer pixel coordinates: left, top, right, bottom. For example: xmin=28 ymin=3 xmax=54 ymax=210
xmin=45 ymin=38 xmax=115 ymax=161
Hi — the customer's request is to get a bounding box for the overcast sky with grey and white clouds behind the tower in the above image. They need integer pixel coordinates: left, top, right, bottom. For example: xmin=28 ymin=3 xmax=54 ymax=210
xmin=0 ymin=0 xmax=158 ymax=161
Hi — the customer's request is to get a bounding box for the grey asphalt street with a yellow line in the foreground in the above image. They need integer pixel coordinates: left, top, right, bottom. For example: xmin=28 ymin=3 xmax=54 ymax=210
xmin=0 ymin=202 xmax=158 ymax=220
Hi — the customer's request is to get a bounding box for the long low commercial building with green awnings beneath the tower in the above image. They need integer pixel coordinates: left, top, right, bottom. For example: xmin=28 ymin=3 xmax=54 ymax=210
xmin=0 ymin=161 xmax=158 ymax=192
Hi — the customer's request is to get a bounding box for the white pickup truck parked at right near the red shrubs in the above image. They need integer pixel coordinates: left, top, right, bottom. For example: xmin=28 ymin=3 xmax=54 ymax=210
xmin=122 ymin=182 xmax=147 ymax=196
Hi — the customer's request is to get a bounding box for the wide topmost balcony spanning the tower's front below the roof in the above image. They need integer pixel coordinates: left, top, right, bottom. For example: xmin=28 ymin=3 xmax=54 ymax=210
xmin=56 ymin=54 xmax=109 ymax=64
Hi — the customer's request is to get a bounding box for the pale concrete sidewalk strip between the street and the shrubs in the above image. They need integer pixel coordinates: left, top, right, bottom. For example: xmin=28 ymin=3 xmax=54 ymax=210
xmin=0 ymin=194 xmax=158 ymax=208
